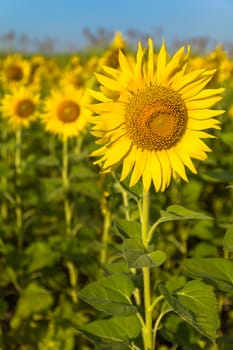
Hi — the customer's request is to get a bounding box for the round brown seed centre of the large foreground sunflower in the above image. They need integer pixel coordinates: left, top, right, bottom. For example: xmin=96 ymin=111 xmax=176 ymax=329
xmin=125 ymin=85 xmax=188 ymax=151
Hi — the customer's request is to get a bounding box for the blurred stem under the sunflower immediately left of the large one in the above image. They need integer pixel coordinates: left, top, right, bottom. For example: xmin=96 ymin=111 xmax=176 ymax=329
xmin=62 ymin=137 xmax=72 ymax=236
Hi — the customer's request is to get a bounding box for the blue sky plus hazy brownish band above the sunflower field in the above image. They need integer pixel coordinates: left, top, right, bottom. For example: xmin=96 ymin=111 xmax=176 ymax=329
xmin=0 ymin=0 xmax=233 ymax=53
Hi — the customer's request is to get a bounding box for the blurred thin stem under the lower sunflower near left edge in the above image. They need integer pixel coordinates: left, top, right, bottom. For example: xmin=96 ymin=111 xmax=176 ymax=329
xmin=15 ymin=128 xmax=23 ymax=248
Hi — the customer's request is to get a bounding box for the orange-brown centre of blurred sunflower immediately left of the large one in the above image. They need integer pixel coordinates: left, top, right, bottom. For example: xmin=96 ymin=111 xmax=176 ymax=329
xmin=57 ymin=100 xmax=80 ymax=123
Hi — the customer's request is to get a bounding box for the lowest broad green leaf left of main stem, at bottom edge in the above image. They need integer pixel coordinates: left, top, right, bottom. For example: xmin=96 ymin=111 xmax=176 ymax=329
xmin=80 ymin=316 xmax=141 ymax=350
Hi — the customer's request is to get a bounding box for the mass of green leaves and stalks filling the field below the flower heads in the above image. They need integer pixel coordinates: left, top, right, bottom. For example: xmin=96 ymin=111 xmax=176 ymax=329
xmin=0 ymin=47 xmax=233 ymax=350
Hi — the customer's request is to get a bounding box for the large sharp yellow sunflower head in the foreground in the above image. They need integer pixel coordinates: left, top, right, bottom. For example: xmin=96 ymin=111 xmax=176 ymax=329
xmin=90 ymin=39 xmax=224 ymax=191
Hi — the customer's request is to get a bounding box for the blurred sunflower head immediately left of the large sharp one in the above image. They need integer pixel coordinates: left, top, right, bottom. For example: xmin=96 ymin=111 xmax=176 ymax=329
xmin=41 ymin=85 xmax=91 ymax=139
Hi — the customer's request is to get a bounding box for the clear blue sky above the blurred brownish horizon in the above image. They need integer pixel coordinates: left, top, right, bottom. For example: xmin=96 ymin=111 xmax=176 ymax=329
xmin=0 ymin=0 xmax=233 ymax=47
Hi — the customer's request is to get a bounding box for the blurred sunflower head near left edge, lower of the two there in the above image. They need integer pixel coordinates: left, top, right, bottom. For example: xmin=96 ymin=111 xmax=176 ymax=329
xmin=1 ymin=85 xmax=40 ymax=129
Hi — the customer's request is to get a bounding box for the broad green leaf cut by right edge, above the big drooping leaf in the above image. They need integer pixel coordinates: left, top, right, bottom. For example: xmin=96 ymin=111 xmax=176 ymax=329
xmin=183 ymin=258 xmax=233 ymax=293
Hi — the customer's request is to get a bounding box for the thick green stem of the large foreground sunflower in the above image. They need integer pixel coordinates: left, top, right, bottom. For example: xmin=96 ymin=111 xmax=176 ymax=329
xmin=141 ymin=191 xmax=153 ymax=350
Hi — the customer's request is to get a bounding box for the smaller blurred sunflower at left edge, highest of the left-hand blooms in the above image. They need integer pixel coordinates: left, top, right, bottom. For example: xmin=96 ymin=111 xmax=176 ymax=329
xmin=0 ymin=54 xmax=31 ymax=88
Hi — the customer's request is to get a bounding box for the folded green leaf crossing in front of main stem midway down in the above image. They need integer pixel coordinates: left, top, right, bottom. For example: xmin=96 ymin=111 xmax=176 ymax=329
xmin=123 ymin=239 xmax=166 ymax=268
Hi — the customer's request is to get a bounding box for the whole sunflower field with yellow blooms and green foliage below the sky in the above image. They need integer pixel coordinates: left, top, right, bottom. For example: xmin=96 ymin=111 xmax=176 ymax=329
xmin=0 ymin=32 xmax=233 ymax=350
